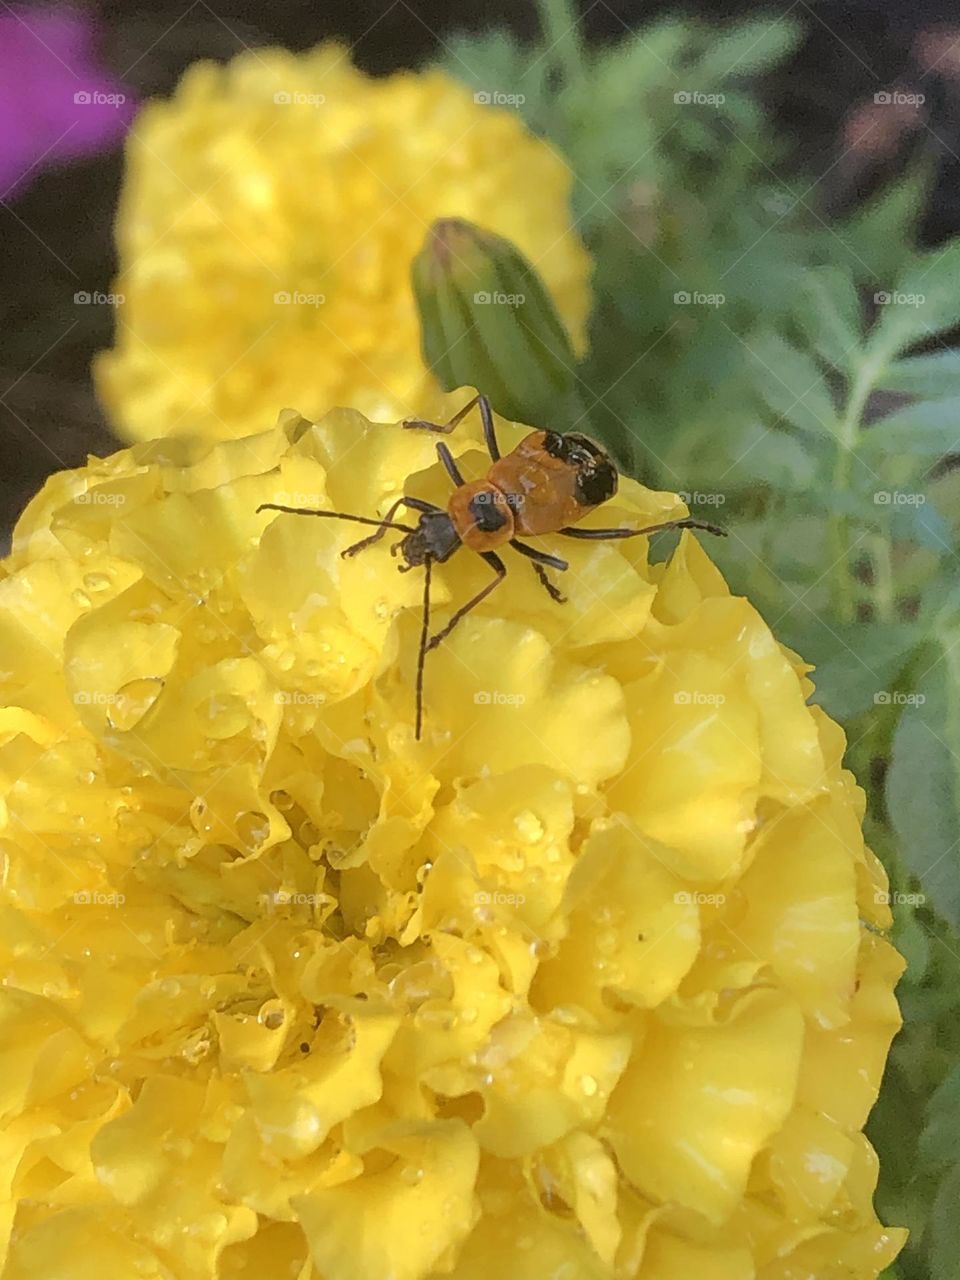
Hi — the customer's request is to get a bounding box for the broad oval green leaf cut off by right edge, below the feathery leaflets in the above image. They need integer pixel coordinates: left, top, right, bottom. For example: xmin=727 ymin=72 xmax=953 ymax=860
xmin=886 ymin=644 xmax=960 ymax=928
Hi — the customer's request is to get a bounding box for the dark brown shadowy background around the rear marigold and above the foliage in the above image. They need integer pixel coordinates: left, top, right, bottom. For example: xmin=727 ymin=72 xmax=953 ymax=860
xmin=0 ymin=0 xmax=960 ymax=534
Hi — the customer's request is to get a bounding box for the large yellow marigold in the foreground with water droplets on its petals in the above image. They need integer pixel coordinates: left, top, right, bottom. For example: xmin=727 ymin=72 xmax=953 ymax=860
xmin=0 ymin=399 xmax=902 ymax=1280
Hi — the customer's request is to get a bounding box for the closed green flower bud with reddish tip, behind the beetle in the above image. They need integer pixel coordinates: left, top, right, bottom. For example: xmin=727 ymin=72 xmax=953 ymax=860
xmin=412 ymin=218 xmax=576 ymax=422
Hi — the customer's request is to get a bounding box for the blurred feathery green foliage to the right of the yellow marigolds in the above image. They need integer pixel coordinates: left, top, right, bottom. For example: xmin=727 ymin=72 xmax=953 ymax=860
xmin=421 ymin=0 xmax=960 ymax=1280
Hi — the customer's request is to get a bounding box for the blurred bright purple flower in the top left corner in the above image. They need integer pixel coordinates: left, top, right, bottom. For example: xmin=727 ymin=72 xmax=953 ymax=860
xmin=0 ymin=8 xmax=134 ymax=198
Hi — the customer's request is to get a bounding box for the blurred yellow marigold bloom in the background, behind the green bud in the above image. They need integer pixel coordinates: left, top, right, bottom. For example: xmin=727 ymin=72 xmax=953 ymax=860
xmin=95 ymin=45 xmax=589 ymax=440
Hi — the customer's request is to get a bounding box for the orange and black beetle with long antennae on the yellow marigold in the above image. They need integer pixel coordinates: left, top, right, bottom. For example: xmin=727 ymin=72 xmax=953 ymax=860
xmin=257 ymin=394 xmax=726 ymax=740
